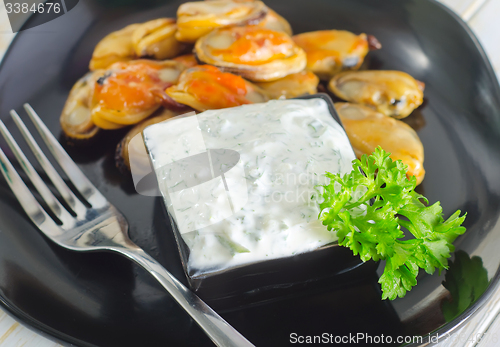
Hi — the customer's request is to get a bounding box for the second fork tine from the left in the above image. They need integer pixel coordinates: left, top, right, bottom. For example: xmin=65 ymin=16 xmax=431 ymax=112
xmin=0 ymin=120 xmax=74 ymax=224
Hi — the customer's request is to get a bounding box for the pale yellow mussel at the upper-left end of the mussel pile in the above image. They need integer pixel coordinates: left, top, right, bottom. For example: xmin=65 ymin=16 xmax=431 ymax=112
xmin=89 ymin=24 xmax=140 ymax=71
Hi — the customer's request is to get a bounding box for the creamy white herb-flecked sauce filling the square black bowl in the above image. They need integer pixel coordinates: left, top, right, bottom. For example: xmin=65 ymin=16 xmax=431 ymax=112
xmin=144 ymin=99 xmax=355 ymax=275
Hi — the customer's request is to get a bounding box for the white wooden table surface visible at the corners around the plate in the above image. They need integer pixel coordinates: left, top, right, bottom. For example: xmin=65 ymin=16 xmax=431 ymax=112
xmin=0 ymin=0 xmax=500 ymax=347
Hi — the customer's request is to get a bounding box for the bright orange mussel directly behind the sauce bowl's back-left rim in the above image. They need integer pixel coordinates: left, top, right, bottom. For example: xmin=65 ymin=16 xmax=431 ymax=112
xmin=165 ymin=65 xmax=268 ymax=111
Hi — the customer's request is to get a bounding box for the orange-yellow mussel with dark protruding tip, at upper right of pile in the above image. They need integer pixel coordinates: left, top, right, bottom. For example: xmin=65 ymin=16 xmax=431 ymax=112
xmin=293 ymin=30 xmax=382 ymax=81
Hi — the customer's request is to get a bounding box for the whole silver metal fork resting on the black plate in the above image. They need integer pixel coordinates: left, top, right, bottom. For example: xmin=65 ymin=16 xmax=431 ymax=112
xmin=0 ymin=104 xmax=253 ymax=347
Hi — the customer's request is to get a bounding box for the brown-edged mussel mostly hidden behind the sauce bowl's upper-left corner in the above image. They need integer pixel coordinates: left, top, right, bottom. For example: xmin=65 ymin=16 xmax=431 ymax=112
xmin=115 ymin=109 xmax=179 ymax=172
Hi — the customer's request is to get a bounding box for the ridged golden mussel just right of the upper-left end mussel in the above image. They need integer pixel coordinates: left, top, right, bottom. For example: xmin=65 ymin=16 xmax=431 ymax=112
xmin=132 ymin=18 xmax=189 ymax=60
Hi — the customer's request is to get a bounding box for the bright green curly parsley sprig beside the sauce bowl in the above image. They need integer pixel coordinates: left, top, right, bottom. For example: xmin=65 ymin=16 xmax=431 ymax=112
xmin=319 ymin=147 xmax=466 ymax=300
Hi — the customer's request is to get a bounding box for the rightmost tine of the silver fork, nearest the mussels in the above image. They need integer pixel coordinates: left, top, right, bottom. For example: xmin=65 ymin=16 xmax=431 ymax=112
xmin=23 ymin=104 xmax=108 ymax=208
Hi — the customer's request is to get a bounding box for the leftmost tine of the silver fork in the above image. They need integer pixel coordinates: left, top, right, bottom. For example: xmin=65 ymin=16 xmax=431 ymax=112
xmin=0 ymin=143 xmax=62 ymax=236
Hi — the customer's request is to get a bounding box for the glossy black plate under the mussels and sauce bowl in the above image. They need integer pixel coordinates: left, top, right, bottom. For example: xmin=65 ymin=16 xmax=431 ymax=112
xmin=0 ymin=0 xmax=500 ymax=346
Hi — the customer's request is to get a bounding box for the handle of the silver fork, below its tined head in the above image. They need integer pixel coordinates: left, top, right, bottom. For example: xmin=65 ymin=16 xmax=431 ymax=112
xmin=119 ymin=248 xmax=254 ymax=347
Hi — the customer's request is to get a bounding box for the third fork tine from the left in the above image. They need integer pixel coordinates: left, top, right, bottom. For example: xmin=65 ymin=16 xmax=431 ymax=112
xmin=10 ymin=110 xmax=87 ymax=215
